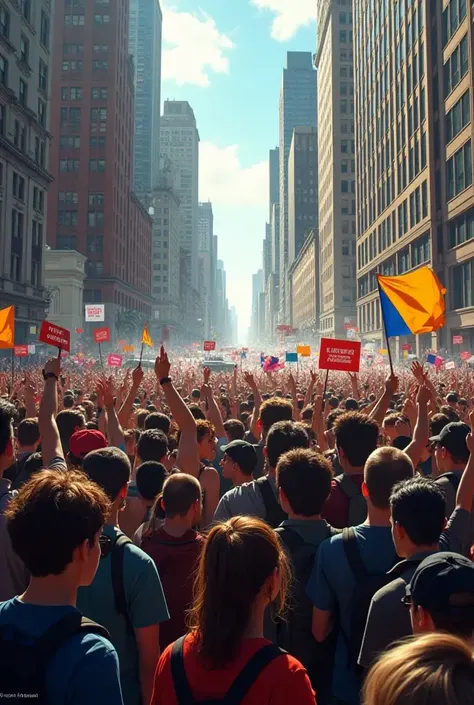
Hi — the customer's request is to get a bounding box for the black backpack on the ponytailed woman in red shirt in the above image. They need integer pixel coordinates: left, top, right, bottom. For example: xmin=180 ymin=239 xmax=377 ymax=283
xmin=171 ymin=636 xmax=286 ymax=705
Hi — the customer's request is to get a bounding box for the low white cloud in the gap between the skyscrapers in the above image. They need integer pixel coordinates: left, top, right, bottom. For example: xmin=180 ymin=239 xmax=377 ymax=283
xmin=199 ymin=142 xmax=268 ymax=206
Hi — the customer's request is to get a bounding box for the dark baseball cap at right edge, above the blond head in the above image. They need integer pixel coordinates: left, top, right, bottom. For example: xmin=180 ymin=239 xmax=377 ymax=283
xmin=403 ymin=551 xmax=474 ymax=613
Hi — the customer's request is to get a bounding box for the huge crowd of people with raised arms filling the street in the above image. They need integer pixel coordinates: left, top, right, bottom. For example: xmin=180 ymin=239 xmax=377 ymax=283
xmin=0 ymin=348 xmax=474 ymax=705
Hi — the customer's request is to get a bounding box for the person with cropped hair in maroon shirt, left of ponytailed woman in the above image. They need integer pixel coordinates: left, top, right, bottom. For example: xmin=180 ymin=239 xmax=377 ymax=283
xmin=141 ymin=473 xmax=204 ymax=651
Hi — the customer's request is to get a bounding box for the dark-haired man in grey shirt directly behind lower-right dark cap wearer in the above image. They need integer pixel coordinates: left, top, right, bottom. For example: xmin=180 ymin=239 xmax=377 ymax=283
xmin=359 ymin=476 xmax=472 ymax=668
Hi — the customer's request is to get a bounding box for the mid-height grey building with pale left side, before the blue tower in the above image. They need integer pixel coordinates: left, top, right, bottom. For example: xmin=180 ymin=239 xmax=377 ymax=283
xmin=288 ymin=127 xmax=318 ymax=267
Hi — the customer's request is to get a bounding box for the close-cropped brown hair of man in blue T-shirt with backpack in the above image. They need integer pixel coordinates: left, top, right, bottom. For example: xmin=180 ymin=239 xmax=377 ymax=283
xmin=364 ymin=447 xmax=414 ymax=509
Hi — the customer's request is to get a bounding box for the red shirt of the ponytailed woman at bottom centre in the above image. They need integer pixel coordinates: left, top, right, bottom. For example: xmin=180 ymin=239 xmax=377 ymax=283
xmin=151 ymin=635 xmax=316 ymax=705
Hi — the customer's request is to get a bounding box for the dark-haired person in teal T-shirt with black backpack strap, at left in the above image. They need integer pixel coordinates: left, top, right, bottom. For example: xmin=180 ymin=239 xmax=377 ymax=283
xmin=77 ymin=448 xmax=169 ymax=705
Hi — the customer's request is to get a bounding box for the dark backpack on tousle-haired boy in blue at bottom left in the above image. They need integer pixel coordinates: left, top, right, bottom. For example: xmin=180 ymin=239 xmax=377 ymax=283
xmin=0 ymin=612 xmax=110 ymax=705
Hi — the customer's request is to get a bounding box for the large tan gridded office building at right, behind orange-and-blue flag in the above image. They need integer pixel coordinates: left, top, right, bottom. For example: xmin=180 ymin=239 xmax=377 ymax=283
xmin=354 ymin=0 xmax=474 ymax=354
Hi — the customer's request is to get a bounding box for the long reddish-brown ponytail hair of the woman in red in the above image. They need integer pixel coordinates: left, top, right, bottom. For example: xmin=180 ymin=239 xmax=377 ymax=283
xmin=188 ymin=517 xmax=291 ymax=669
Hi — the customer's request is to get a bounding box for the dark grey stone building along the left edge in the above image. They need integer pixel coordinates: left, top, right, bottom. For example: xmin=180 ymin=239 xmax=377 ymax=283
xmin=0 ymin=0 xmax=52 ymax=343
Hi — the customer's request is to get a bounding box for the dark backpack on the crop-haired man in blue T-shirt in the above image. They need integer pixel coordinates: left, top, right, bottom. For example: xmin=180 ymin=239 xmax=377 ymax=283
xmin=342 ymin=527 xmax=397 ymax=676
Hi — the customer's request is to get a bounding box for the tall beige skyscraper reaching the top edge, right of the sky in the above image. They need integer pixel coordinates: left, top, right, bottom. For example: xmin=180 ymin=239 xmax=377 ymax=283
xmin=316 ymin=0 xmax=356 ymax=338
